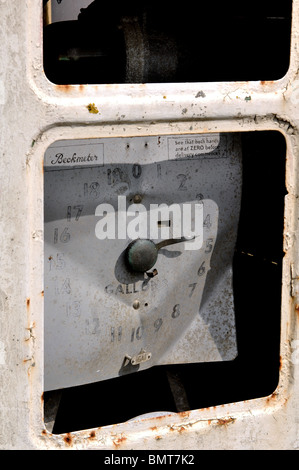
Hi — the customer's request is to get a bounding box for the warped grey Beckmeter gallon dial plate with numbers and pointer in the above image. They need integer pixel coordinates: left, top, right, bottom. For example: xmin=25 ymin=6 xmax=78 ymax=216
xmin=44 ymin=134 xmax=241 ymax=390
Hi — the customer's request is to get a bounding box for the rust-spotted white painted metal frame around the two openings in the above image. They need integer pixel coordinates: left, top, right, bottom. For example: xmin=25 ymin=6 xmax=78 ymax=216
xmin=0 ymin=0 xmax=299 ymax=450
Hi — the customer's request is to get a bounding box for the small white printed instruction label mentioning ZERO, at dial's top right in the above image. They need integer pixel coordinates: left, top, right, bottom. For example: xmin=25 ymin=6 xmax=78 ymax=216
xmin=168 ymin=134 xmax=220 ymax=160
